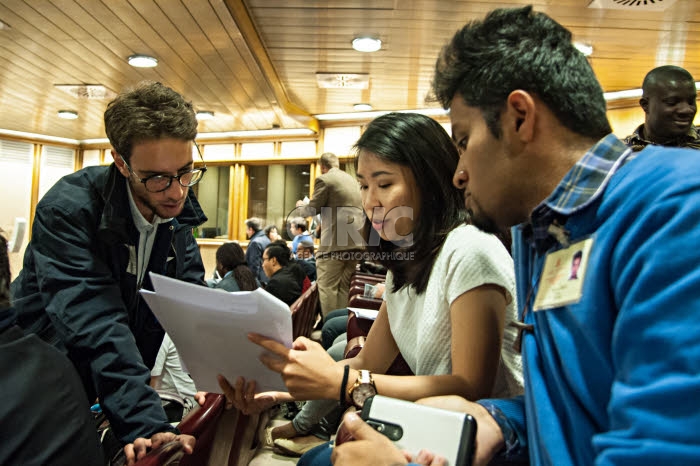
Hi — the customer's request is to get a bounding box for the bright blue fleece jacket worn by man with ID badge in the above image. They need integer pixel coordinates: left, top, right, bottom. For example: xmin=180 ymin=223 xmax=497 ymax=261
xmin=480 ymin=136 xmax=700 ymax=466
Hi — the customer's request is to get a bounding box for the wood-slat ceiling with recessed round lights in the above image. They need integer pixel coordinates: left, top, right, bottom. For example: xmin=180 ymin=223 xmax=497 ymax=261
xmin=0 ymin=0 xmax=700 ymax=140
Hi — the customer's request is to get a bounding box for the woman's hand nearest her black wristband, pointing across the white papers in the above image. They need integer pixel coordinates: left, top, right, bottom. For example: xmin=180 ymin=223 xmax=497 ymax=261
xmin=248 ymin=333 xmax=344 ymax=400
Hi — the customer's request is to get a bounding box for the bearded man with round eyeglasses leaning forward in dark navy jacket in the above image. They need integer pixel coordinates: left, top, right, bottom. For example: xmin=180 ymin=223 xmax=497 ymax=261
xmin=12 ymin=82 xmax=206 ymax=462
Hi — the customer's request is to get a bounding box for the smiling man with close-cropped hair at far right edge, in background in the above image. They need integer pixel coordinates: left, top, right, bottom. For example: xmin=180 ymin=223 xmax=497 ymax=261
xmin=625 ymin=65 xmax=700 ymax=151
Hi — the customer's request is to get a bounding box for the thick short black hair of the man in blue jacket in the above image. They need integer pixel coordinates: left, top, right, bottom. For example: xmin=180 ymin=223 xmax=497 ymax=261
xmin=432 ymin=6 xmax=612 ymax=139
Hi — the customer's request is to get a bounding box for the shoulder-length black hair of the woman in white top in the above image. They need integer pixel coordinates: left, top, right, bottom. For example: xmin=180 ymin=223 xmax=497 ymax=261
xmin=355 ymin=113 xmax=467 ymax=293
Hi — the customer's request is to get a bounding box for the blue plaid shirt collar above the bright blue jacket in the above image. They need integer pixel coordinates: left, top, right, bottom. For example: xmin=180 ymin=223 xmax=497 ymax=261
xmin=519 ymin=134 xmax=632 ymax=252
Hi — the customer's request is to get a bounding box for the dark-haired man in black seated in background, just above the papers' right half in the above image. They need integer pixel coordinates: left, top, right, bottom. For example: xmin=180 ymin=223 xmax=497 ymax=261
xmin=262 ymin=240 xmax=307 ymax=305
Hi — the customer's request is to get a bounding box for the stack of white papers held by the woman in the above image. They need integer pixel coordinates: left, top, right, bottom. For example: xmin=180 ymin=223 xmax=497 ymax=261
xmin=141 ymin=273 xmax=292 ymax=393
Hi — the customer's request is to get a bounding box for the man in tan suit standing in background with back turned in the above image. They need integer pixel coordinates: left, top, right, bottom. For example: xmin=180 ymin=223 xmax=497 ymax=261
xmin=297 ymin=152 xmax=364 ymax=316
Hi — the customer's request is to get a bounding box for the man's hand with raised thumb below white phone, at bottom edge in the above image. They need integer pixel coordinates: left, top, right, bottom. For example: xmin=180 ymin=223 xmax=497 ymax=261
xmin=331 ymin=412 xmax=445 ymax=466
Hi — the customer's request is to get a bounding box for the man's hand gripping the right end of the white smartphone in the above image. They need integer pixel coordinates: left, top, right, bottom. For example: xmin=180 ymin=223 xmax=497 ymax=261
xmin=416 ymin=395 xmax=505 ymax=466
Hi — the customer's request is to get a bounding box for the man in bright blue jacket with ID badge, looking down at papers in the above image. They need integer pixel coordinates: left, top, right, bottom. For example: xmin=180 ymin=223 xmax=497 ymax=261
xmin=334 ymin=7 xmax=700 ymax=466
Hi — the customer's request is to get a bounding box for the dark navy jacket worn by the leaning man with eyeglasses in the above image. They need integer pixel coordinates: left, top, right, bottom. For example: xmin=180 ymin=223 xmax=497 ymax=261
xmin=12 ymin=165 xmax=206 ymax=442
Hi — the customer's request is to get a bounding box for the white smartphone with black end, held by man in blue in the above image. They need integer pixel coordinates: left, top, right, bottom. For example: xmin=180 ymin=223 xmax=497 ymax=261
xmin=361 ymin=395 xmax=476 ymax=466
